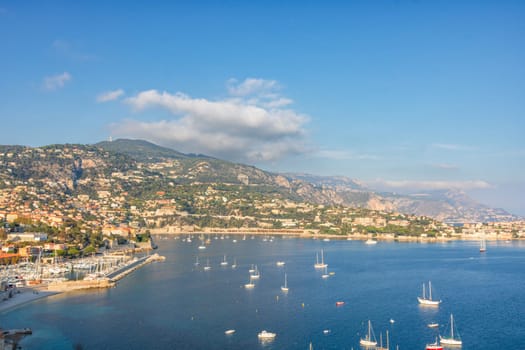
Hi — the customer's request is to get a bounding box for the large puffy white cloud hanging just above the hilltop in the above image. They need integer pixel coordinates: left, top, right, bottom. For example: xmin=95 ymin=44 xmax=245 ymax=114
xmin=112 ymin=79 xmax=308 ymax=161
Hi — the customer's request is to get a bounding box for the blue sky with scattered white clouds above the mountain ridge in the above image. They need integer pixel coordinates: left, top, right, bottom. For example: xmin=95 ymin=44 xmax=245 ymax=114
xmin=0 ymin=0 xmax=525 ymax=215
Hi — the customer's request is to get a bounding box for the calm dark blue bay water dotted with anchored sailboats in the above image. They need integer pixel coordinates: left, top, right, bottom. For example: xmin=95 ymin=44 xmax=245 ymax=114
xmin=0 ymin=235 xmax=525 ymax=350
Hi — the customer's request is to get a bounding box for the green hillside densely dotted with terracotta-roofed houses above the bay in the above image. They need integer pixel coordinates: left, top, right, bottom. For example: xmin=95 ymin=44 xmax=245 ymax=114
xmin=0 ymin=145 xmax=525 ymax=266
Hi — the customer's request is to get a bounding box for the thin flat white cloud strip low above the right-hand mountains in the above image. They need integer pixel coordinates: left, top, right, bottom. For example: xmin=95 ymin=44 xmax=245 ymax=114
xmin=368 ymin=180 xmax=492 ymax=190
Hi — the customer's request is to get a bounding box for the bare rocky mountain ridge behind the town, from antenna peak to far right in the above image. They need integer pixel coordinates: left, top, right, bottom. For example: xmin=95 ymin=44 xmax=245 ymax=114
xmin=97 ymin=140 xmax=518 ymax=222
